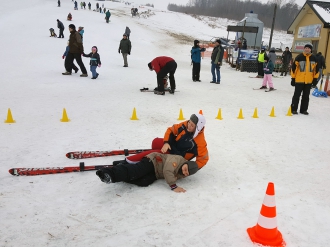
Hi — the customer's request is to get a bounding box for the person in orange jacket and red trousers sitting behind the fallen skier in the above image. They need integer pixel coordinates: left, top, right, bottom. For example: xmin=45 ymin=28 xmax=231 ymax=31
xmin=114 ymin=114 xmax=209 ymax=169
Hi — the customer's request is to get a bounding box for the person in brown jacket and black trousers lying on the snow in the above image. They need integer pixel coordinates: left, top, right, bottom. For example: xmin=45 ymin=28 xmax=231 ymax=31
xmin=96 ymin=153 xmax=198 ymax=193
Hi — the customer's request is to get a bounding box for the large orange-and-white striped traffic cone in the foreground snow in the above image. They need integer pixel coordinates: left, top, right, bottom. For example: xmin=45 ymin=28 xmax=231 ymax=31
xmin=247 ymin=183 xmax=286 ymax=247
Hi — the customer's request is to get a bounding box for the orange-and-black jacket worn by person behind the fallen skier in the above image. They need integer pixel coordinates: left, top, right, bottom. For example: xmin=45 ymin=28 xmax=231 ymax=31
xmin=164 ymin=120 xmax=209 ymax=169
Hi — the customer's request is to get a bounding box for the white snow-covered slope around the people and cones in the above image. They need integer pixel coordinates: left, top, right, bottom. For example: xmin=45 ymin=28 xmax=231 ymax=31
xmin=0 ymin=0 xmax=330 ymax=247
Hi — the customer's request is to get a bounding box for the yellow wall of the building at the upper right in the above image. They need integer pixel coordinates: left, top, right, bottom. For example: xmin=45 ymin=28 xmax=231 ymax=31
xmin=292 ymin=9 xmax=330 ymax=74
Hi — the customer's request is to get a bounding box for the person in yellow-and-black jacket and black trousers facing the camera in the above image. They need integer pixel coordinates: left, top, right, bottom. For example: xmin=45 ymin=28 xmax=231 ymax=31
xmin=291 ymin=44 xmax=319 ymax=115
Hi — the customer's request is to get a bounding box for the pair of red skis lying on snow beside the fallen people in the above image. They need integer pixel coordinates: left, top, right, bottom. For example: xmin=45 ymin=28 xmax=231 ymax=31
xmin=9 ymin=149 xmax=150 ymax=176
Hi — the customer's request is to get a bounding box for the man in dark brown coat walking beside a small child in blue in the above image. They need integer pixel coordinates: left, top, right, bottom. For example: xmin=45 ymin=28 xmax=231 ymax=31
xmin=62 ymin=24 xmax=88 ymax=77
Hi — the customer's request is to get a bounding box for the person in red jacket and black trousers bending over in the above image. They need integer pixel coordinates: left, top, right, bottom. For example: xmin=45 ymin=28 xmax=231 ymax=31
xmin=148 ymin=56 xmax=177 ymax=95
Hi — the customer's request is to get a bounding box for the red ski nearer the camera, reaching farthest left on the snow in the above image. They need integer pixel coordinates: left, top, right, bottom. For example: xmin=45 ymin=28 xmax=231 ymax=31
xmin=9 ymin=162 xmax=113 ymax=176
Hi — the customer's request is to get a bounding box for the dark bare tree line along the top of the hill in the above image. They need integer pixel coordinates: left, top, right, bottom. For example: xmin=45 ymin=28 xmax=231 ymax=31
xmin=167 ymin=0 xmax=300 ymax=31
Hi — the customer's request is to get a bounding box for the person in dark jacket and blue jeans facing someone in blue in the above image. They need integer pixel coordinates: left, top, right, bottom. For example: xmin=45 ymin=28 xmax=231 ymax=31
xmin=210 ymin=39 xmax=224 ymax=84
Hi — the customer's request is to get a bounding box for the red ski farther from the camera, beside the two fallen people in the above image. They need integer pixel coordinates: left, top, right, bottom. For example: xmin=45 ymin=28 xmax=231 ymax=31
xmin=66 ymin=149 xmax=151 ymax=159
